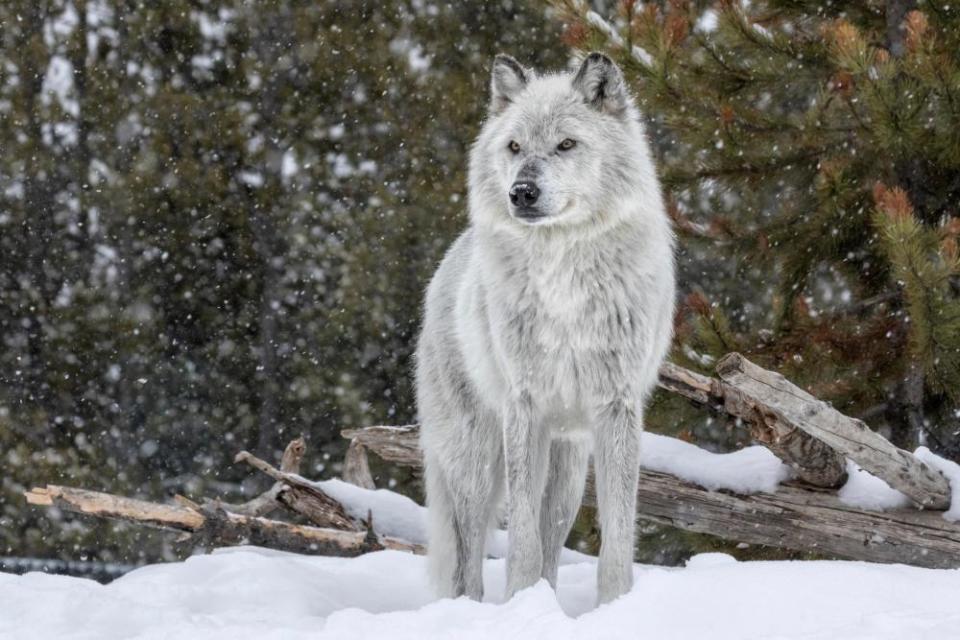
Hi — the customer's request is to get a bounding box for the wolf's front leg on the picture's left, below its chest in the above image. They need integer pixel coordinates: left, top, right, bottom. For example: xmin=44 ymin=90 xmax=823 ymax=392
xmin=503 ymin=393 xmax=549 ymax=598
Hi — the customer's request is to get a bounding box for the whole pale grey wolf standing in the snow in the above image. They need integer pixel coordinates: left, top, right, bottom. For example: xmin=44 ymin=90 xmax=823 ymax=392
xmin=416 ymin=53 xmax=675 ymax=603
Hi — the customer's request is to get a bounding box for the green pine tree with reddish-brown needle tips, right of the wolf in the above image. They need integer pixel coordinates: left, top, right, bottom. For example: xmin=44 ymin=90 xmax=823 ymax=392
xmin=552 ymin=0 xmax=960 ymax=459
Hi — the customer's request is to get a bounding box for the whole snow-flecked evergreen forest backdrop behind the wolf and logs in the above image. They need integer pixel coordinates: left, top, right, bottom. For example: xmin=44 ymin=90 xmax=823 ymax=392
xmin=0 ymin=0 xmax=960 ymax=563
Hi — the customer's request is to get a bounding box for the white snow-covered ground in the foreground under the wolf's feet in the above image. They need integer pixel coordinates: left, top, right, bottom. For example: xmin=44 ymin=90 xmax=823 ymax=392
xmin=0 ymin=547 xmax=960 ymax=640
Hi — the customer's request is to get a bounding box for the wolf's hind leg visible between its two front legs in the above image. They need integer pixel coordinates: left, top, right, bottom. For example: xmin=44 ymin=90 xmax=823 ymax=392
xmin=540 ymin=439 xmax=590 ymax=589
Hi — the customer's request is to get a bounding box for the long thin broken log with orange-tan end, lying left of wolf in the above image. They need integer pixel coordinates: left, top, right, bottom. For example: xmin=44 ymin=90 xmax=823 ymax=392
xmin=26 ymin=485 xmax=423 ymax=557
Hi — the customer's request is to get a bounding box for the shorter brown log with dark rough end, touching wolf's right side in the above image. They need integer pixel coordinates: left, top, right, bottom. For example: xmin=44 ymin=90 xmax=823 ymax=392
xmin=659 ymin=362 xmax=847 ymax=488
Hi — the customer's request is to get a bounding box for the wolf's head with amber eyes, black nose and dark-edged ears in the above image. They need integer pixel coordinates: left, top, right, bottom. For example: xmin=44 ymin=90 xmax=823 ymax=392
xmin=470 ymin=53 xmax=659 ymax=232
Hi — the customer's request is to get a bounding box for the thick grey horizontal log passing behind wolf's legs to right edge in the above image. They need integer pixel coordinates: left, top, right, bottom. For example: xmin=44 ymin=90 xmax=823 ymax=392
xmin=343 ymin=426 xmax=960 ymax=568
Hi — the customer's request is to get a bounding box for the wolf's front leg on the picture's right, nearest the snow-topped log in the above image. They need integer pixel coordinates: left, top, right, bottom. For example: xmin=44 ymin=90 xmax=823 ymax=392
xmin=594 ymin=400 xmax=643 ymax=604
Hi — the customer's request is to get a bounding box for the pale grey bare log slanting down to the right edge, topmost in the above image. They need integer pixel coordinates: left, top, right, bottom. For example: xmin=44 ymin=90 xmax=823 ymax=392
xmin=717 ymin=353 xmax=950 ymax=509
